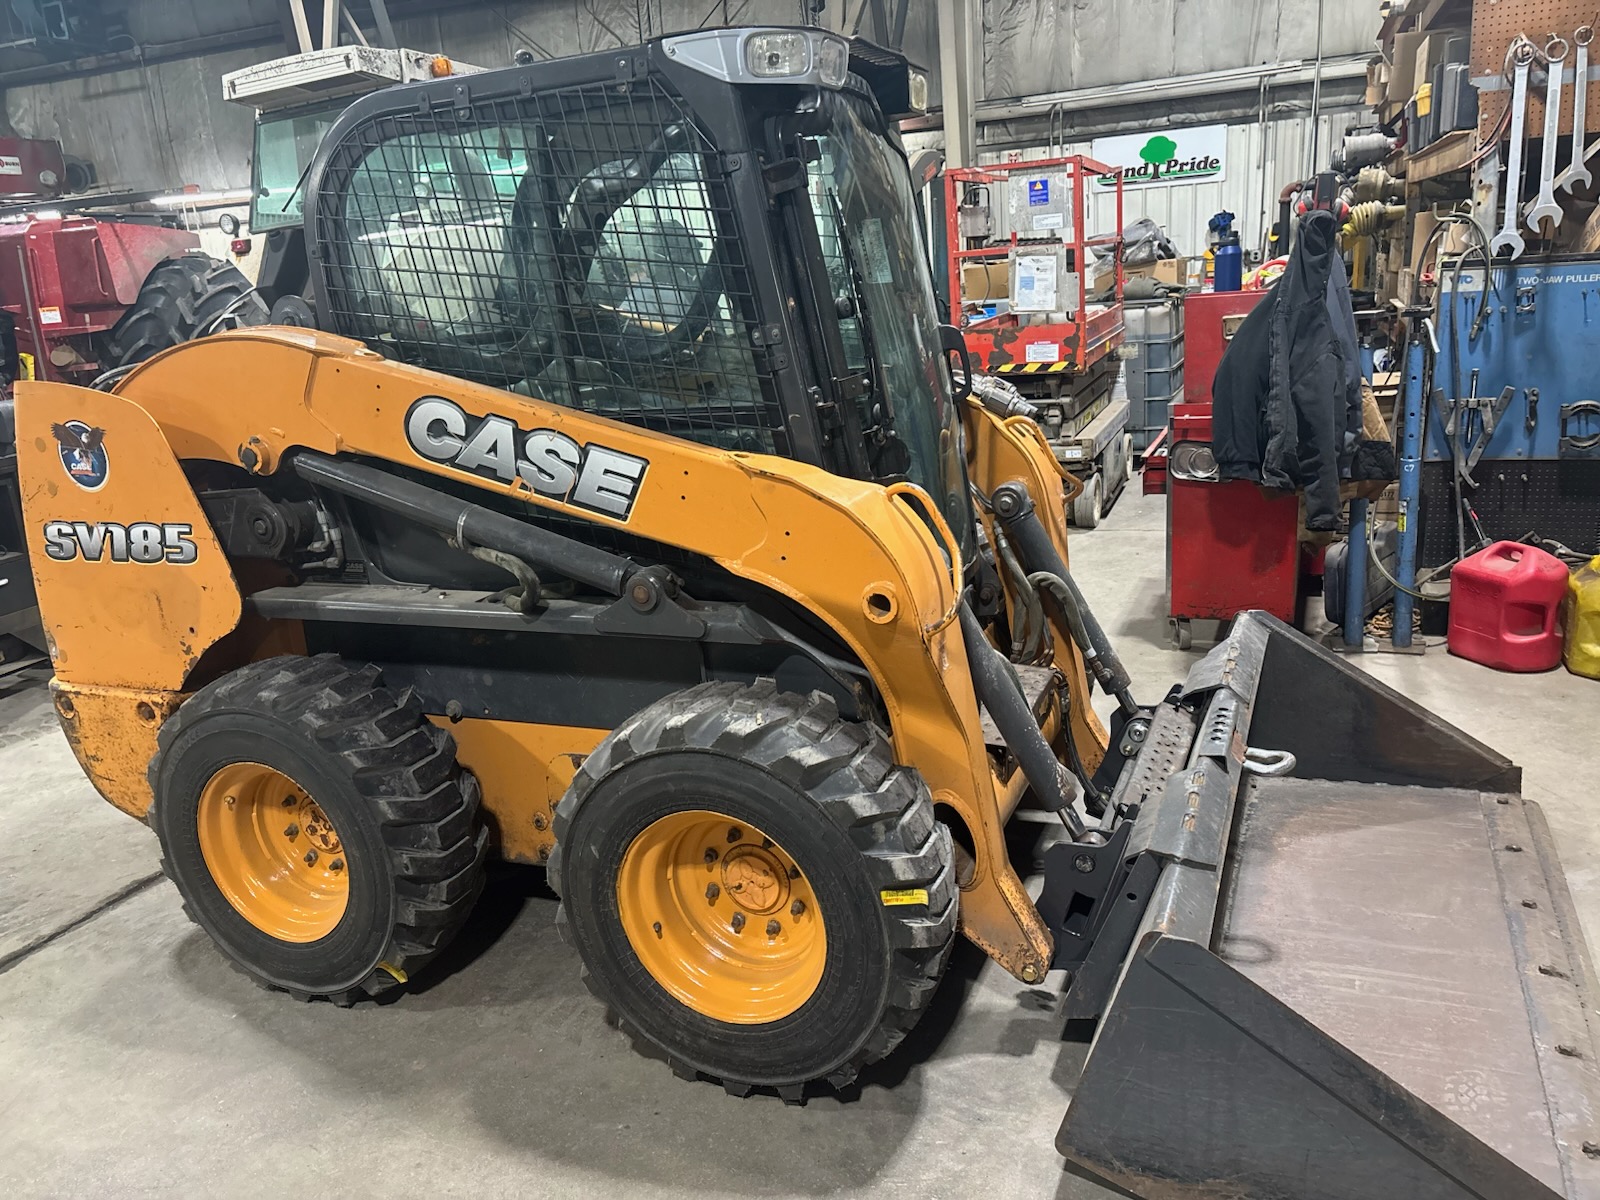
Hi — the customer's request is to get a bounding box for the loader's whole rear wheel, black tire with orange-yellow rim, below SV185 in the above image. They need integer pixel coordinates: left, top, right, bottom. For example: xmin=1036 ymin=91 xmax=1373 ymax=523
xmin=146 ymin=654 xmax=488 ymax=1005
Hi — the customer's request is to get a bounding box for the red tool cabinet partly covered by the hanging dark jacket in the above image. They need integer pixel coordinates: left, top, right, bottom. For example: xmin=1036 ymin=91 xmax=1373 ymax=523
xmin=1164 ymin=291 xmax=1299 ymax=650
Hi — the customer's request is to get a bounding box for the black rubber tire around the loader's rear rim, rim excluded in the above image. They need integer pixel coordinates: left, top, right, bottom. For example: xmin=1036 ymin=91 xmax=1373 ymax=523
xmin=147 ymin=654 xmax=488 ymax=1003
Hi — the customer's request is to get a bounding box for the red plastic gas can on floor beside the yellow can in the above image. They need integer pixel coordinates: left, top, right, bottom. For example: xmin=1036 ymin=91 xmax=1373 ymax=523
xmin=1450 ymin=542 xmax=1566 ymax=670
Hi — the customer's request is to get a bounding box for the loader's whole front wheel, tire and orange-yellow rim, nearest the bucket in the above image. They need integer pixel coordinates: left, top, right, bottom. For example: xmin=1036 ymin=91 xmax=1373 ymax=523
xmin=549 ymin=682 xmax=958 ymax=1102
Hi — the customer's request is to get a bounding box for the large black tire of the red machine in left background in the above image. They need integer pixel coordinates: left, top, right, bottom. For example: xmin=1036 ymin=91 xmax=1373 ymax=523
xmin=110 ymin=254 xmax=267 ymax=366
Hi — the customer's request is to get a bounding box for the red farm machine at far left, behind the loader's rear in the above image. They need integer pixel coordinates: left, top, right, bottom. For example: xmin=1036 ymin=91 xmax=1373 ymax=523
xmin=0 ymin=214 xmax=200 ymax=382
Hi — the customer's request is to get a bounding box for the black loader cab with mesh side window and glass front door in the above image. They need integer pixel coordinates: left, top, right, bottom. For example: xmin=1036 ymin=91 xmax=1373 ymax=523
xmin=300 ymin=29 xmax=974 ymax=560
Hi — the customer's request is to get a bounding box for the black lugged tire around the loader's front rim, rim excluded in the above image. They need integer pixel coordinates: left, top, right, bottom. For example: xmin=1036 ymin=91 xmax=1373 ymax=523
xmin=549 ymin=682 xmax=957 ymax=1099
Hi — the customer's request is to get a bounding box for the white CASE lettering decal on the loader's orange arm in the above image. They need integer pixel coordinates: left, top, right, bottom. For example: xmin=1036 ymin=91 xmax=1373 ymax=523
xmin=405 ymin=395 xmax=650 ymax=520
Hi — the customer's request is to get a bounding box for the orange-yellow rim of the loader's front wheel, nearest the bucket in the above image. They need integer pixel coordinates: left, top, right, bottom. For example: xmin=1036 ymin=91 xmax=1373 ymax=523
xmin=616 ymin=810 xmax=827 ymax=1026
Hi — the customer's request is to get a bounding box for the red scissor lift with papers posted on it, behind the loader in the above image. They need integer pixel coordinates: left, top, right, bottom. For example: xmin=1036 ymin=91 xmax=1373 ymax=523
xmin=944 ymin=155 xmax=1133 ymax=525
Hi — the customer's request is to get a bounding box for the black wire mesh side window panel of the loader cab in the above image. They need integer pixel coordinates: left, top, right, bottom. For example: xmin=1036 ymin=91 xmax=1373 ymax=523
xmin=318 ymin=80 xmax=787 ymax=453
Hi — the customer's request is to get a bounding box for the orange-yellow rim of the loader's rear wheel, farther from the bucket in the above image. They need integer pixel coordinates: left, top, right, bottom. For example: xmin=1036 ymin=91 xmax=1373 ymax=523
xmin=198 ymin=763 xmax=350 ymax=942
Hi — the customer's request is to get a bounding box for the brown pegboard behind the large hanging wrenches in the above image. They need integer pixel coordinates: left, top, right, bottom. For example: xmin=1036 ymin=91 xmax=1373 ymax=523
xmin=1472 ymin=0 xmax=1600 ymax=142
